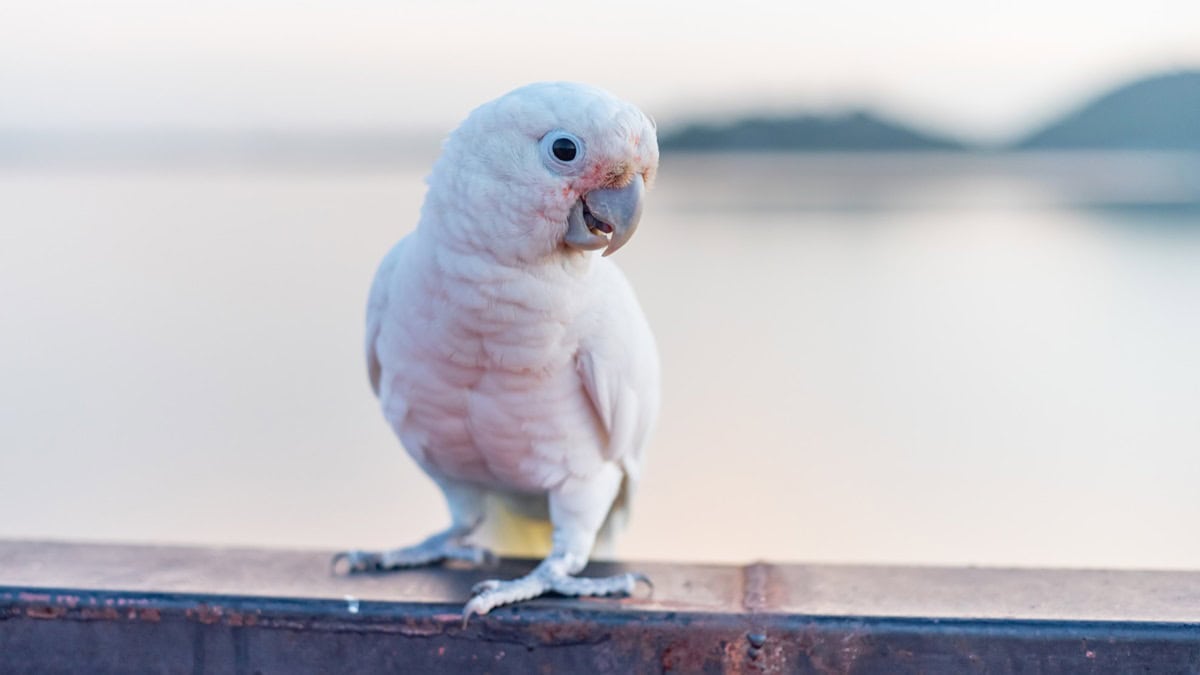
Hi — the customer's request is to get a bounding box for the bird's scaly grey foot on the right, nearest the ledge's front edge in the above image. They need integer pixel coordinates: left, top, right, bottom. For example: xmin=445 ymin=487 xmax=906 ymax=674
xmin=462 ymin=569 xmax=654 ymax=625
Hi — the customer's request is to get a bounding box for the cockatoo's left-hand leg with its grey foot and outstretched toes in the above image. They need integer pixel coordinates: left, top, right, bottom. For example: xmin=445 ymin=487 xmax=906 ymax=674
xmin=334 ymin=482 xmax=496 ymax=574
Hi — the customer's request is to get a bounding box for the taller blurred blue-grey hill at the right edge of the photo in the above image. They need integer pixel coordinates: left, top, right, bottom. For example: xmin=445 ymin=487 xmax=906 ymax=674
xmin=1015 ymin=71 xmax=1200 ymax=150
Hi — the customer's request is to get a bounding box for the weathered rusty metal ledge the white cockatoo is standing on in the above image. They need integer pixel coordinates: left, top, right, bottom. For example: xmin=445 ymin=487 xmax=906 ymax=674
xmin=0 ymin=540 xmax=1200 ymax=675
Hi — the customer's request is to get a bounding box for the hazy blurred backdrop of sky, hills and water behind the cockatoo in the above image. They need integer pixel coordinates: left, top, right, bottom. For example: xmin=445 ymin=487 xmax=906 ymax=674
xmin=0 ymin=0 xmax=1200 ymax=568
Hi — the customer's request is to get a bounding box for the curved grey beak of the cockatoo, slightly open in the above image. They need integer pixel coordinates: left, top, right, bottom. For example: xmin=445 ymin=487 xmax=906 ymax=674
xmin=564 ymin=174 xmax=646 ymax=256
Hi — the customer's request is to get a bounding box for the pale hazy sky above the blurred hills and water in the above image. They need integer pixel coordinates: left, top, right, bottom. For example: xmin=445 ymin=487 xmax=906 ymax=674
xmin=0 ymin=0 xmax=1200 ymax=139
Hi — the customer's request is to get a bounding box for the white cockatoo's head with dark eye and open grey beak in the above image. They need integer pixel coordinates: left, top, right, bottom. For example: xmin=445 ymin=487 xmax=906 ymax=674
xmin=422 ymin=83 xmax=659 ymax=259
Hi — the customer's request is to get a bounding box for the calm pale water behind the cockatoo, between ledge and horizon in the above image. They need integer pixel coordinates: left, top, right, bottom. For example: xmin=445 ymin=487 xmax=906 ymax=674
xmin=0 ymin=156 xmax=1200 ymax=567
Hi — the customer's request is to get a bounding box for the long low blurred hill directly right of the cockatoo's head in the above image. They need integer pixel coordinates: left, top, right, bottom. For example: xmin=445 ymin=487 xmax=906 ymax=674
xmin=659 ymin=112 xmax=965 ymax=151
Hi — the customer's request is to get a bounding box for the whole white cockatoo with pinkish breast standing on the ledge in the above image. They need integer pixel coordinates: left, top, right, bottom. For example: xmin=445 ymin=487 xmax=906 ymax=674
xmin=335 ymin=83 xmax=660 ymax=620
